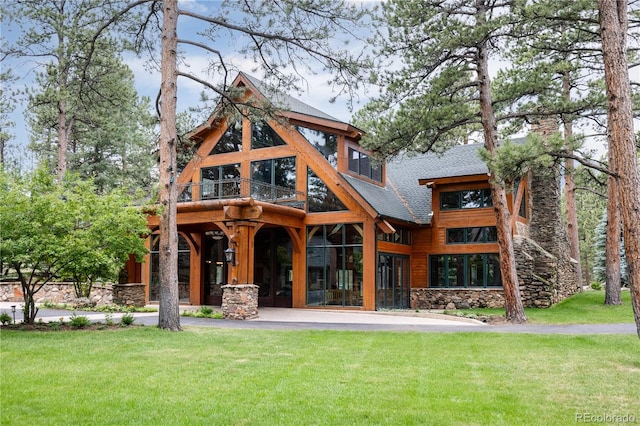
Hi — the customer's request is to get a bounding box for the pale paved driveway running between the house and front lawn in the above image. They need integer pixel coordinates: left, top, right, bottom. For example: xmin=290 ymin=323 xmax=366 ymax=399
xmin=0 ymin=302 xmax=636 ymax=334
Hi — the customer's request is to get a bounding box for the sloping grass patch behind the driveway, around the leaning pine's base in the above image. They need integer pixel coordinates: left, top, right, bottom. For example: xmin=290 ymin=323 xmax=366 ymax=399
xmin=447 ymin=290 xmax=640 ymax=322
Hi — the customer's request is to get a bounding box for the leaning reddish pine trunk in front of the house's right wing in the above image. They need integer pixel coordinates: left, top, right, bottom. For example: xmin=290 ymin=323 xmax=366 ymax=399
xmin=476 ymin=0 xmax=527 ymax=323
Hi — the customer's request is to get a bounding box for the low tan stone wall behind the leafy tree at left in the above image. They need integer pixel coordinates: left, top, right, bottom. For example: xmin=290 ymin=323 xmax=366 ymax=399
xmin=0 ymin=282 xmax=112 ymax=305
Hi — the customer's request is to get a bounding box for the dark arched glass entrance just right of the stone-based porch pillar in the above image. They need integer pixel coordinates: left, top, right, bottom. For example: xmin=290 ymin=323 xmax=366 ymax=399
xmin=253 ymin=228 xmax=293 ymax=308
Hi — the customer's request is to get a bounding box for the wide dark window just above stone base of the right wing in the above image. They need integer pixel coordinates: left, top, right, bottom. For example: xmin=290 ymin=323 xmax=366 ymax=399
xmin=429 ymin=253 xmax=502 ymax=288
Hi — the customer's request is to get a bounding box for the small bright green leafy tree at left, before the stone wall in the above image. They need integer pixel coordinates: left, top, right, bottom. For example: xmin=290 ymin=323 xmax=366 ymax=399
xmin=0 ymin=167 xmax=148 ymax=323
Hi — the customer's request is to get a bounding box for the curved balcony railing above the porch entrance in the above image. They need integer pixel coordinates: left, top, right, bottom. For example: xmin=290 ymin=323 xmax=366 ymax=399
xmin=178 ymin=178 xmax=305 ymax=210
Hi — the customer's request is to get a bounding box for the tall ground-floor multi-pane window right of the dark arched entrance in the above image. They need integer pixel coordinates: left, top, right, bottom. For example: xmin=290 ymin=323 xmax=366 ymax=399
xmin=307 ymin=223 xmax=363 ymax=306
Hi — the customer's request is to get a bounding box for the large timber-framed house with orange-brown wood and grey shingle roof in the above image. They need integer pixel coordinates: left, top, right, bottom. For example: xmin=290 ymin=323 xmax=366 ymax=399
xmin=129 ymin=73 xmax=580 ymax=319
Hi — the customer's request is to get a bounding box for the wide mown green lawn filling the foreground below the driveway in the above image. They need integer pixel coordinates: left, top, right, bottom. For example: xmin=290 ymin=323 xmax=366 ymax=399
xmin=0 ymin=327 xmax=640 ymax=425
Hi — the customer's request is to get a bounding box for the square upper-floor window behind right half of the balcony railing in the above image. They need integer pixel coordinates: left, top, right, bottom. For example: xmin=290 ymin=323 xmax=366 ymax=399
xmin=251 ymin=157 xmax=296 ymax=200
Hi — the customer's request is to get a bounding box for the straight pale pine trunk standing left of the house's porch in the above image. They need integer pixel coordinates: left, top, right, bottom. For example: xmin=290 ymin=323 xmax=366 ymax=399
xmin=158 ymin=0 xmax=182 ymax=331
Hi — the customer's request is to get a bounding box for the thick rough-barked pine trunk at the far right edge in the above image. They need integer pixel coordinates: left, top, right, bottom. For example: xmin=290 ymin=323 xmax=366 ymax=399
xmin=598 ymin=0 xmax=640 ymax=337
